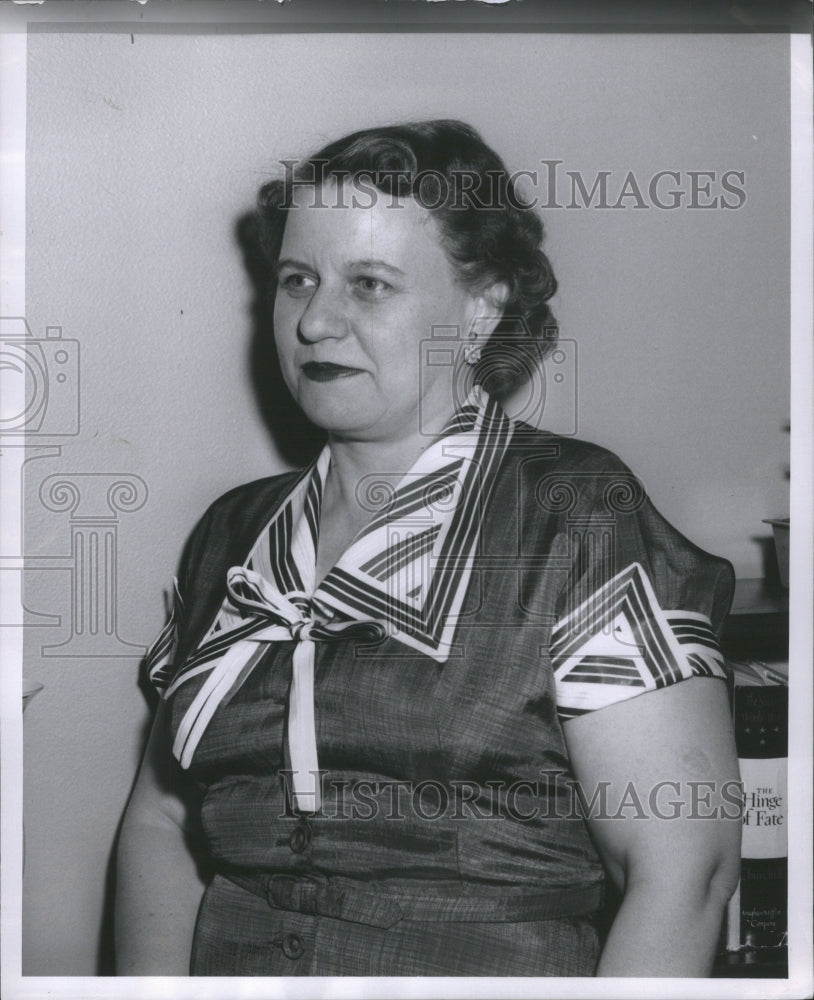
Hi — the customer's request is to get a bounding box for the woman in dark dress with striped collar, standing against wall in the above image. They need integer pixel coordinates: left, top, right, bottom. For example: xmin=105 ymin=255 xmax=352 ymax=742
xmin=117 ymin=121 xmax=740 ymax=976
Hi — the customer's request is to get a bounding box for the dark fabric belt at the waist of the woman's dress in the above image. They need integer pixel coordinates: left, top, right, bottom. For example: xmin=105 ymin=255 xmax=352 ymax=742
xmin=221 ymin=872 xmax=602 ymax=928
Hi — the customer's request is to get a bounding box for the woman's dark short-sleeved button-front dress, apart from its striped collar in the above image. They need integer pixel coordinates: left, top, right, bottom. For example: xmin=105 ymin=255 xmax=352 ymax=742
xmin=148 ymin=386 xmax=732 ymax=976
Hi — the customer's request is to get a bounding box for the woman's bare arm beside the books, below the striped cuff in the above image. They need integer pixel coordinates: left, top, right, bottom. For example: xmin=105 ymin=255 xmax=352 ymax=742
xmin=564 ymin=678 xmax=741 ymax=976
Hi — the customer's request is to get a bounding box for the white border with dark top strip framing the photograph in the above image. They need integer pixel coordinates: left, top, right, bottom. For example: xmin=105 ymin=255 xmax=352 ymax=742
xmin=0 ymin=0 xmax=814 ymax=1000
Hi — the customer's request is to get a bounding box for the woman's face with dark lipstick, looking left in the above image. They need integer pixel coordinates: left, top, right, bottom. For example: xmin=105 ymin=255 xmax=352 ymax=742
xmin=274 ymin=181 xmax=484 ymax=442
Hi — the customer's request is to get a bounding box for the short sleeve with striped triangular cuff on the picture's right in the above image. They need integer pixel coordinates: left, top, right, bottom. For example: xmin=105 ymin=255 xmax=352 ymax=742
xmin=551 ymin=450 xmax=734 ymax=721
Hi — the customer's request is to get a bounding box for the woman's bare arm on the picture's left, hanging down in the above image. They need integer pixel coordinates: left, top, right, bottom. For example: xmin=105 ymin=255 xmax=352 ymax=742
xmin=115 ymin=701 xmax=210 ymax=976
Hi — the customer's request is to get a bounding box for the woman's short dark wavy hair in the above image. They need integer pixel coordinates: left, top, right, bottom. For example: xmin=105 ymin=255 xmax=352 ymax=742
xmin=258 ymin=119 xmax=557 ymax=399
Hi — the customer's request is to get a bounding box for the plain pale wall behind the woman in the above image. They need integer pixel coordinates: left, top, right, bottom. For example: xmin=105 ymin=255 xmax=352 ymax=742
xmin=23 ymin=34 xmax=789 ymax=975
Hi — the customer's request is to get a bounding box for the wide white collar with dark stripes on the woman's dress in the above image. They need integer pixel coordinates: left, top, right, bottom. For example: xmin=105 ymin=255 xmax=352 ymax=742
xmin=168 ymin=387 xmax=514 ymax=694
